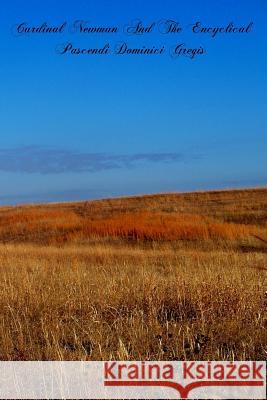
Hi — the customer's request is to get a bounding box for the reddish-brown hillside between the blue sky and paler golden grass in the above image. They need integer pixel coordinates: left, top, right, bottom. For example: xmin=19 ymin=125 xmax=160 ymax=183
xmin=0 ymin=189 xmax=267 ymax=251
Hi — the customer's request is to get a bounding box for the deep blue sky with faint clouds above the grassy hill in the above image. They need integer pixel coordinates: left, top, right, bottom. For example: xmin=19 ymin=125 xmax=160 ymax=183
xmin=0 ymin=0 xmax=267 ymax=204
